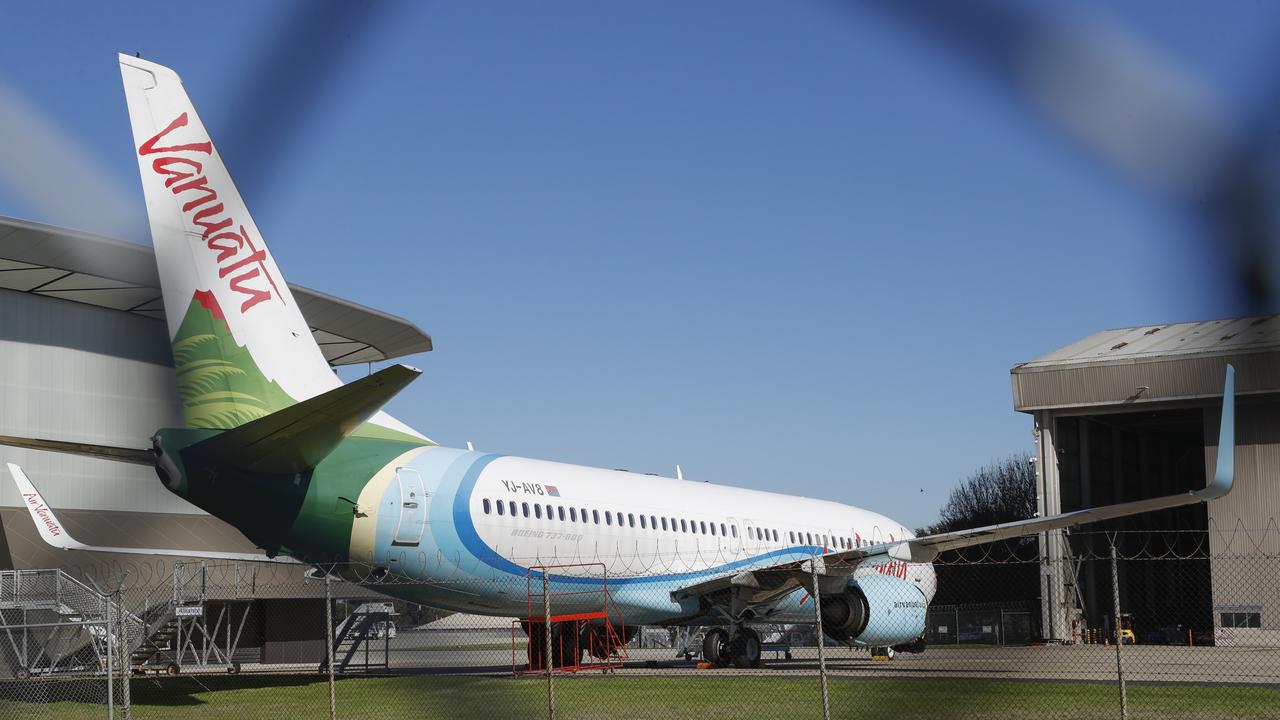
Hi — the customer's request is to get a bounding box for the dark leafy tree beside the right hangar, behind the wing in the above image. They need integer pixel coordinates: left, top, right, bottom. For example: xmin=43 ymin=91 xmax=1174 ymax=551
xmin=927 ymin=452 xmax=1036 ymax=533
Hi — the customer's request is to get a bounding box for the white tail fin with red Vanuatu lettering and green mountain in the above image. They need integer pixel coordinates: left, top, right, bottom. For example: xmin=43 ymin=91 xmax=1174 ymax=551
xmin=119 ymin=54 xmax=426 ymax=441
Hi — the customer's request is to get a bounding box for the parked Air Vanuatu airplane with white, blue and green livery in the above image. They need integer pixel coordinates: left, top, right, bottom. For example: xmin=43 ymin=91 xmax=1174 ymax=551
xmin=0 ymin=55 xmax=1235 ymax=667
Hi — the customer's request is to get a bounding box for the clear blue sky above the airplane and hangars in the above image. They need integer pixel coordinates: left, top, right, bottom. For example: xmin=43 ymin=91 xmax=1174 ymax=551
xmin=0 ymin=1 xmax=1280 ymax=525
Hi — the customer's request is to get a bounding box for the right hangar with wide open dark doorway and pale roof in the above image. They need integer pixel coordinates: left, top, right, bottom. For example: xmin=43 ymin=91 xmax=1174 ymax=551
xmin=1011 ymin=315 xmax=1280 ymax=644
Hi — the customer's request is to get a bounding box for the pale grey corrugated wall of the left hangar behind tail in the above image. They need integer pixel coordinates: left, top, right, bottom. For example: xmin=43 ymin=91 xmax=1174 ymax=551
xmin=0 ymin=291 xmax=189 ymax=514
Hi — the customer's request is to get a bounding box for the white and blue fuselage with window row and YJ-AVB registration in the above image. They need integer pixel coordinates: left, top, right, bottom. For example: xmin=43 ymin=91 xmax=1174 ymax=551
xmin=352 ymin=447 xmax=934 ymax=623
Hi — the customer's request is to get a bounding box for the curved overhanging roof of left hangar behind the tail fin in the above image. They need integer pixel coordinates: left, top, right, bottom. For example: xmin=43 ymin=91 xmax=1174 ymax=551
xmin=0 ymin=215 xmax=431 ymax=365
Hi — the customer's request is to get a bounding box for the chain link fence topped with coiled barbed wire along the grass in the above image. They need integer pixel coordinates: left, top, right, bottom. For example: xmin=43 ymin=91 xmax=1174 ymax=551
xmin=0 ymin=528 xmax=1280 ymax=720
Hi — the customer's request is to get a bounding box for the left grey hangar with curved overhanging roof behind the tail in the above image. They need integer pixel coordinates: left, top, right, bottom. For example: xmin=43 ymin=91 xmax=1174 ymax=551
xmin=0 ymin=211 xmax=431 ymax=589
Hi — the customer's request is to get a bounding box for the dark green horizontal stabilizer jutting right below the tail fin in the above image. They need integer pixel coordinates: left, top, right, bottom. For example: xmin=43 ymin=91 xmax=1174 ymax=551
xmin=187 ymin=365 xmax=422 ymax=475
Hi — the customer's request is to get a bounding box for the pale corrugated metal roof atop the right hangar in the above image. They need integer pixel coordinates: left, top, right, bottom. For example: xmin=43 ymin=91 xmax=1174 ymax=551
xmin=1015 ymin=315 xmax=1280 ymax=372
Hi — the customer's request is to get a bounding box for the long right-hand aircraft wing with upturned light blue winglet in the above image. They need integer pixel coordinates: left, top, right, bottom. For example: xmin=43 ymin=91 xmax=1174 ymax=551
xmin=672 ymin=365 xmax=1235 ymax=610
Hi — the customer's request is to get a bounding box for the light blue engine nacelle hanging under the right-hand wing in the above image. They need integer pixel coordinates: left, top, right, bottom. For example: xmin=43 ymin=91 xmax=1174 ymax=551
xmin=822 ymin=575 xmax=925 ymax=647
